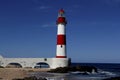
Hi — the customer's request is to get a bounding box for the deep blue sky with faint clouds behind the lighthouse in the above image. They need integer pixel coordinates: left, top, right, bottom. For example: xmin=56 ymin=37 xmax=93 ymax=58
xmin=0 ymin=0 xmax=120 ymax=63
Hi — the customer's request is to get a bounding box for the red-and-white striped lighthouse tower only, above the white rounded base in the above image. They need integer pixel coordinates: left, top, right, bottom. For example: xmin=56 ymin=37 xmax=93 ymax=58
xmin=56 ymin=9 xmax=67 ymax=58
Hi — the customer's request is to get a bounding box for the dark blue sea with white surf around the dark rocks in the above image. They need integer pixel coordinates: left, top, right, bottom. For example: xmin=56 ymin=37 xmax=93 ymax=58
xmin=30 ymin=63 xmax=120 ymax=80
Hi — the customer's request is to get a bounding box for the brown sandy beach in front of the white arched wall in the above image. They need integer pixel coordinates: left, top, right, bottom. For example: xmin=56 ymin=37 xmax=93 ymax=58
xmin=0 ymin=68 xmax=49 ymax=80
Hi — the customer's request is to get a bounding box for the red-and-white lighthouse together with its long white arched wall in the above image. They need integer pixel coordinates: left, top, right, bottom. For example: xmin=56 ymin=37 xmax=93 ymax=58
xmin=0 ymin=9 xmax=71 ymax=69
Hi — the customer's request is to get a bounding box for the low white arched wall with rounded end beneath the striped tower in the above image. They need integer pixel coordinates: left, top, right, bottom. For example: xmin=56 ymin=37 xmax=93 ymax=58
xmin=0 ymin=56 xmax=70 ymax=68
